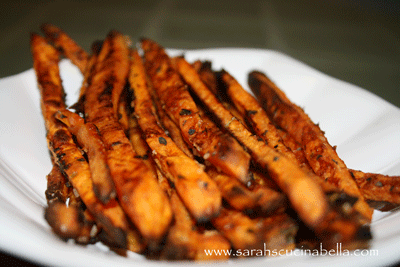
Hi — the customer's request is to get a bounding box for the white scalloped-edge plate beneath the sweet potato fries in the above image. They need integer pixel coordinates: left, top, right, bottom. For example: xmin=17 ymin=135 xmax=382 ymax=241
xmin=0 ymin=49 xmax=400 ymax=267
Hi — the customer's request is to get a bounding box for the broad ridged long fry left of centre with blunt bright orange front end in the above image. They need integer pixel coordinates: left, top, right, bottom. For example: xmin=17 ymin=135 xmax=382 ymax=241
xmin=85 ymin=31 xmax=172 ymax=247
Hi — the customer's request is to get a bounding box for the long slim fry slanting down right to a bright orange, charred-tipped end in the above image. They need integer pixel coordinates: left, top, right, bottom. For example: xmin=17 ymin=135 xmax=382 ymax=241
xmin=177 ymin=58 xmax=370 ymax=251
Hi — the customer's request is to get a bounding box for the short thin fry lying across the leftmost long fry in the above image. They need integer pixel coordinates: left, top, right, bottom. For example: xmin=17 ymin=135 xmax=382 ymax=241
xmin=55 ymin=109 xmax=116 ymax=204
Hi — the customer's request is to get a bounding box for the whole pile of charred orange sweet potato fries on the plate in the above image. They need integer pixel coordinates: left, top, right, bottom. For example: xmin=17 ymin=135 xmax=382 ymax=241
xmin=31 ymin=24 xmax=400 ymax=260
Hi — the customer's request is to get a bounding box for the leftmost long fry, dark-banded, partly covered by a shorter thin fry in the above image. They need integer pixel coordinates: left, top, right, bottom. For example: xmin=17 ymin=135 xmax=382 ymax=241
xmin=31 ymin=34 xmax=128 ymax=251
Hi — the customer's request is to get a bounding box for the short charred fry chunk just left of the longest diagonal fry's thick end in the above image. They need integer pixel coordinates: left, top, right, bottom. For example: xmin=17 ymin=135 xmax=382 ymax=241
xmin=207 ymin=168 xmax=286 ymax=214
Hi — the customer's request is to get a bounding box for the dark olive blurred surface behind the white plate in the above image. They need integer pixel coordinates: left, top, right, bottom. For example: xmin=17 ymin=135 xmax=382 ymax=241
xmin=0 ymin=0 xmax=400 ymax=266
